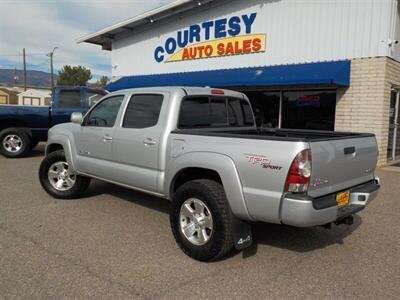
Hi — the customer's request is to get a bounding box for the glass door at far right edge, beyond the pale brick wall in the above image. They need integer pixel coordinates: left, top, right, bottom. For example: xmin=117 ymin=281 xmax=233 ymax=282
xmin=387 ymin=89 xmax=400 ymax=161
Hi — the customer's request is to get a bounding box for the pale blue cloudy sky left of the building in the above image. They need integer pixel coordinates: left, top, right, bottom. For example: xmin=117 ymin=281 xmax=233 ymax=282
xmin=0 ymin=0 xmax=172 ymax=79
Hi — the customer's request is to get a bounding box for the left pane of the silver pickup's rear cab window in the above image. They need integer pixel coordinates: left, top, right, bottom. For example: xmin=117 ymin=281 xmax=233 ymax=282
xmin=179 ymin=97 xmax=211 ymax=128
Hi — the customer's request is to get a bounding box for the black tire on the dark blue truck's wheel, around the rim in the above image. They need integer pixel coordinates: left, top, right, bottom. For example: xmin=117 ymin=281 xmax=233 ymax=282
xmin=0 ymin=128 xmax=31 ymax=158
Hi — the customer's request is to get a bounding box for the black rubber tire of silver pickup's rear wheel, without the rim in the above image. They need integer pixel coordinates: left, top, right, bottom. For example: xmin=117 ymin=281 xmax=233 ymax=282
xmin=170 ymin=179 xmax=234 ymax=261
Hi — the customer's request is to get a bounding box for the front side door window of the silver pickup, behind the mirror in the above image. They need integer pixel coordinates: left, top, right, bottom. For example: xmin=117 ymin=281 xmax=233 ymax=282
xmin=86 ymin=95 xmax=124 ymax=127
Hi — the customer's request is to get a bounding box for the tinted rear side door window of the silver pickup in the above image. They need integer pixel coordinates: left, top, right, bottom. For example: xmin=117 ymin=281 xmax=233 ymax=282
xmin=123 ymin=95 xmax=164 ymax=128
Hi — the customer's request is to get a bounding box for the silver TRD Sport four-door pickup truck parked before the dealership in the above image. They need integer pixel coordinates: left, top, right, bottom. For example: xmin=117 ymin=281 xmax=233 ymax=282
xmin=39 ymin=87 xmax=380 ymax=261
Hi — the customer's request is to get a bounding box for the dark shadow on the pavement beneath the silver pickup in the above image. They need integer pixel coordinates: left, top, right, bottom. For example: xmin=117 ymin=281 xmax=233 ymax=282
xmin=85 ymin=180 xmax=362 ymax=259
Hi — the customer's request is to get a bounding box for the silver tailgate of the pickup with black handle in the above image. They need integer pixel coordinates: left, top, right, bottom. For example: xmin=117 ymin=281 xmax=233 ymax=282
xmin=309 ymin=135 xmax=378 ymax=197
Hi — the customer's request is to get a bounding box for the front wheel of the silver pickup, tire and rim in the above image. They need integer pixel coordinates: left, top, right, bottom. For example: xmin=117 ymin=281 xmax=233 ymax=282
xmin=39 ymin=150 xmax=90 ymax=199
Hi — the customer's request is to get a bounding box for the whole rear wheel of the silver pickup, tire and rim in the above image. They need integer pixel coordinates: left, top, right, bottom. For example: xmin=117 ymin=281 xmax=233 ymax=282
xmin=170 ymin=179 xmax=234 ymax=261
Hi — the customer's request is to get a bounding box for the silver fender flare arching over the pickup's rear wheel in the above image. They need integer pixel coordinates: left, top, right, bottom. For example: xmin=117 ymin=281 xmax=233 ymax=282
xmin=164 ymin=152 xmax=252 ymax=221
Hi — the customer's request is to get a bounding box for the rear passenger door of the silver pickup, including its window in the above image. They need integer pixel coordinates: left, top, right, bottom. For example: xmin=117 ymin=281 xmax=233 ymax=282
xmin=112 ymin=94 xmax=166 ymax=191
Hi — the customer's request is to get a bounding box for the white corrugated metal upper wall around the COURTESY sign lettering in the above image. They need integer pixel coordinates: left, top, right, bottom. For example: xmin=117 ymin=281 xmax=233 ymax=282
xmin=112 ymin=0 xmax=400 ymax=76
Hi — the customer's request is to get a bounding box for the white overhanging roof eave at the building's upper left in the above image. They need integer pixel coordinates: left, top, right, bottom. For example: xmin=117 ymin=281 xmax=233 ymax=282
xmin=76 ymin=0 xmax=215 ymax=50
